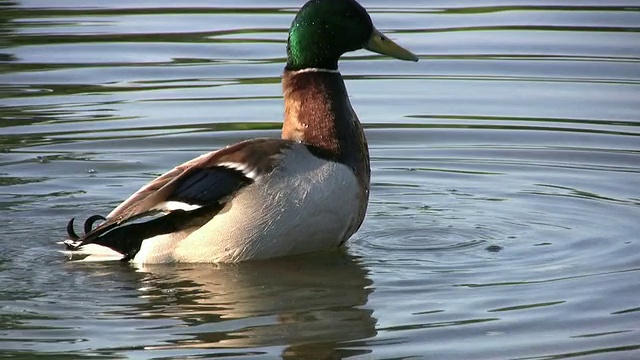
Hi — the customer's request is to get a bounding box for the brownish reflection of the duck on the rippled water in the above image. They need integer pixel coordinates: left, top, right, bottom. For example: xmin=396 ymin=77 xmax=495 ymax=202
xmin=133 ymin=251 xmax=376 ymax=357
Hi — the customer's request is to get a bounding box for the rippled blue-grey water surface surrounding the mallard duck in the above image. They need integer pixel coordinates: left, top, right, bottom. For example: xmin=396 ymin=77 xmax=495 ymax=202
xmin=0 ymin=0 xmax=640 ymax=359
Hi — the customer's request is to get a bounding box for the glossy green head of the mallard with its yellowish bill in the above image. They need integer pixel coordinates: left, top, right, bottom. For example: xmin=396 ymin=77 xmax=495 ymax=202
xmin=287 ymin=0 xmax=418 ymax=70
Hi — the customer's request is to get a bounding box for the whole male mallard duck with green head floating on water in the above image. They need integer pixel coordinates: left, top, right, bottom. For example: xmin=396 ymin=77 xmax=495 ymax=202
xmin=62 ymin=0 xmax=418 ymax=264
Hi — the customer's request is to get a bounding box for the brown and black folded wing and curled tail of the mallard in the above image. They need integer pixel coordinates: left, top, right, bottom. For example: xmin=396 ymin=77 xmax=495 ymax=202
xmin=65 ymin=139 xmax=293 ymax=260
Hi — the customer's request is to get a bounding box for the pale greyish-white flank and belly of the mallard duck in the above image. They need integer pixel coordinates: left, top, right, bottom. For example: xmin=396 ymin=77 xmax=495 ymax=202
xmin=133 ymin=144 xmax=359 ymax=263
